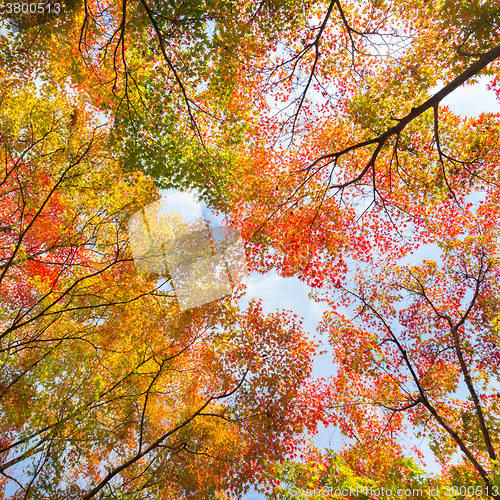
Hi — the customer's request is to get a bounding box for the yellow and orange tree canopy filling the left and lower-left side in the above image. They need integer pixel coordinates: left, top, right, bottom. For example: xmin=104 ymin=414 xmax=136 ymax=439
xmin=0 ymin=82 xmax=315 ymax=499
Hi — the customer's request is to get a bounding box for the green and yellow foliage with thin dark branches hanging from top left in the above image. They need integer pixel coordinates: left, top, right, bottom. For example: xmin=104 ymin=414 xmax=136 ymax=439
xmin=3 ymin=0 xmax=332 ymax=203
